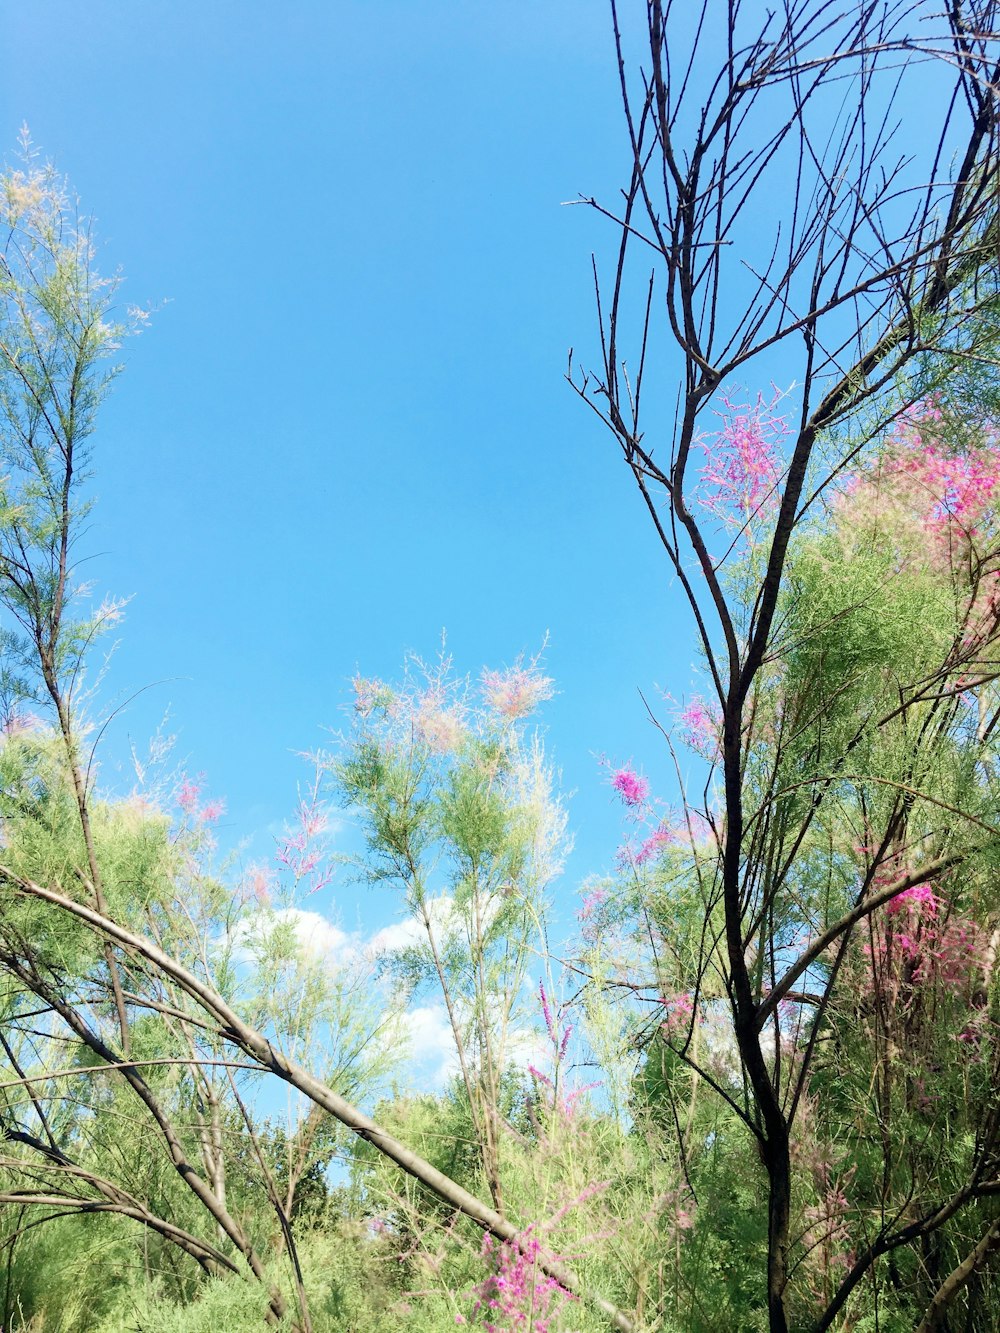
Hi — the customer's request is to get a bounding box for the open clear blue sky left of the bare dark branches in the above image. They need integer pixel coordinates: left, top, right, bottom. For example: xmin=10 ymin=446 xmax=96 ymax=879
xmin=0 ymin=0 xmax=695 ymax=938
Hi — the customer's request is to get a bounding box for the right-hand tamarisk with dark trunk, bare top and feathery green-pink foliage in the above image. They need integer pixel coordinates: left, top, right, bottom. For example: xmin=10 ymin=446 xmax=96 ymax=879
xmin=569 ymin=0 xmax=1000 ymax=1333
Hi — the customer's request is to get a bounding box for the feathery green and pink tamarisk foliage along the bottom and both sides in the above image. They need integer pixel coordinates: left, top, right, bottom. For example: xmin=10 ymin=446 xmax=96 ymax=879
xmin=0 ymin=127 xmax=1000 ymax=1333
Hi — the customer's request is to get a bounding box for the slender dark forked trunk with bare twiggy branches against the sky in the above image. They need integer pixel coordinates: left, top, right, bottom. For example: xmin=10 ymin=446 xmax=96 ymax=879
xmin=569 ymin=0 xmax=1000 ymax=1333
